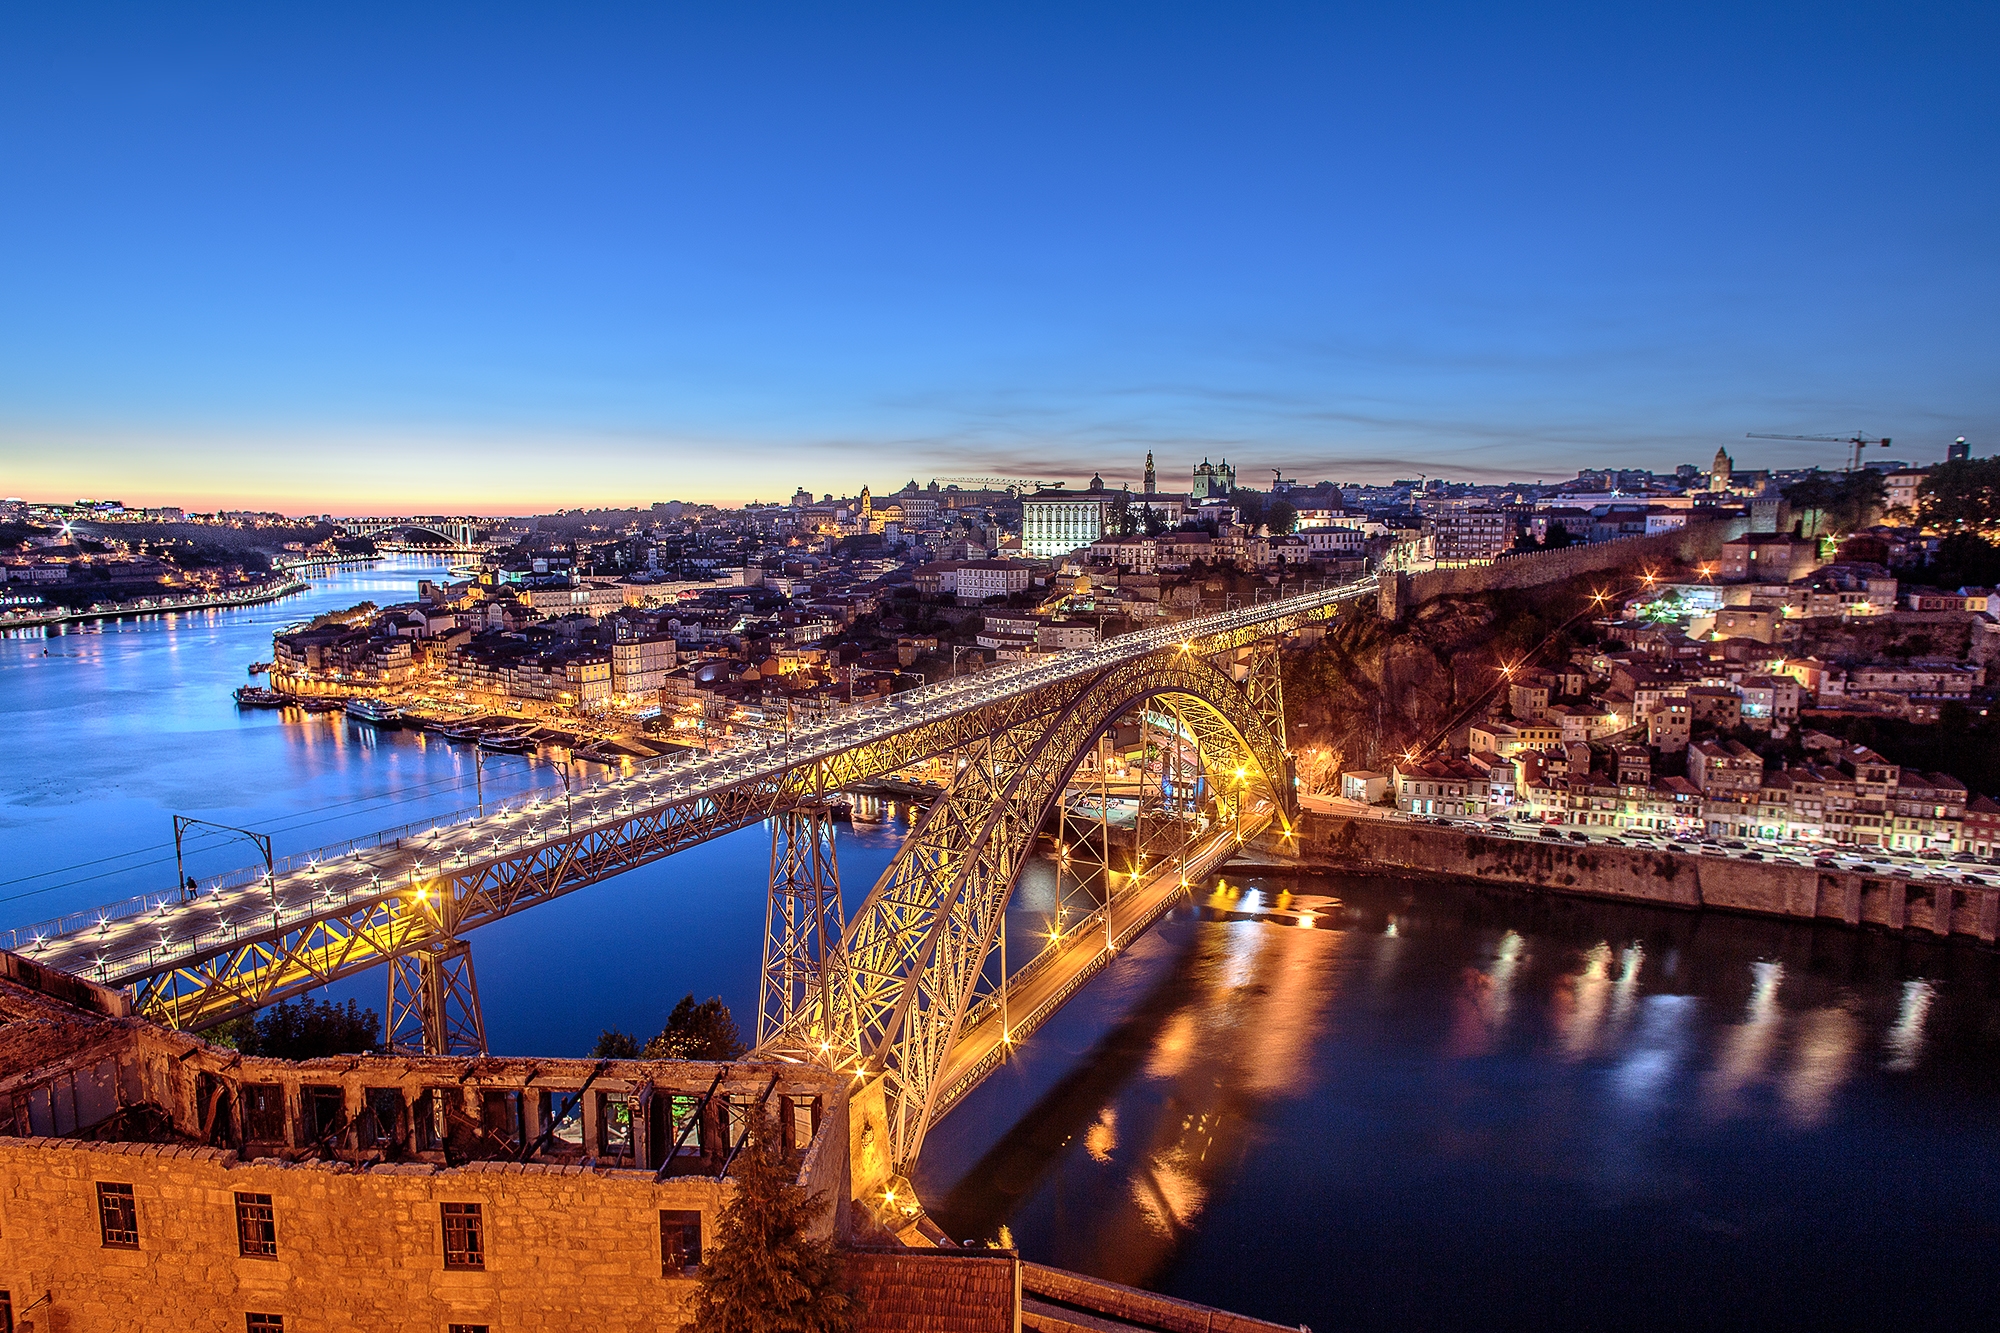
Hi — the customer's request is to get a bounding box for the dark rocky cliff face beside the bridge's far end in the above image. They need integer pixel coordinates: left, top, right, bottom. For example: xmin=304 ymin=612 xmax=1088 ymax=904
xmin=1284 ymin=584 xmax=1584 ymax=773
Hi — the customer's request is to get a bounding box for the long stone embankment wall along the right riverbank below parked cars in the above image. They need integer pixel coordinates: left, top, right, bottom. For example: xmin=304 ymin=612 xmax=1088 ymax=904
xmin=1298 ymin=811 xmax=2000 ymax=945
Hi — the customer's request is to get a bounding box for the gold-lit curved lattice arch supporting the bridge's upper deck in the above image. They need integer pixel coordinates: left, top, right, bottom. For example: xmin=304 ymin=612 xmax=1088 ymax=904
xmin=788 ymin=650 xmax=1284 ymax=1169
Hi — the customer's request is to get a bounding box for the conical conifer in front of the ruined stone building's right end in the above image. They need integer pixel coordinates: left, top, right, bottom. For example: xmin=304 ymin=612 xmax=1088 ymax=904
xmin=690 ymin=1125 xmax=856 ymax=1333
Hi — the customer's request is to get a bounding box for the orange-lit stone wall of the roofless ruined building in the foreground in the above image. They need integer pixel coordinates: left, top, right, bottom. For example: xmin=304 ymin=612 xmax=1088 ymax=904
xmin=0 ymin=1139 xmax=724 ymax=1333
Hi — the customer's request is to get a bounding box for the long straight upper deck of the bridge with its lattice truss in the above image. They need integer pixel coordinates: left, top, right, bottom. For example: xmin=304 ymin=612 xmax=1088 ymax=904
xmin=62 ymin=582 xmax=1374 ymax=1029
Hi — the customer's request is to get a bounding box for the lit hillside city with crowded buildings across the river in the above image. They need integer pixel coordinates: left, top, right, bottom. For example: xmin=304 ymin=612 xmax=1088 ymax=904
xmin=0 ymin=442 xmax=2000 ymax=859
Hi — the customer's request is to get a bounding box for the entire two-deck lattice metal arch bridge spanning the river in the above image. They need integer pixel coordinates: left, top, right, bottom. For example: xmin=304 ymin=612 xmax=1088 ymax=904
xmin=10 ymin=580 xmax=1378 ymax=1171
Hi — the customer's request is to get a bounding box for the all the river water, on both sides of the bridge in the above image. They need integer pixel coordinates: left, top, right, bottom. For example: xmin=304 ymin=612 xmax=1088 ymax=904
xmin=0 ymin=560 xmax=2000 ymax=1333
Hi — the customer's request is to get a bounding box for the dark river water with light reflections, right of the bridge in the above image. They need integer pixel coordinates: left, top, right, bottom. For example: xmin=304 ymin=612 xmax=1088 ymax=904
xmin=918 ymin=877 xmax=2000 ymax=1329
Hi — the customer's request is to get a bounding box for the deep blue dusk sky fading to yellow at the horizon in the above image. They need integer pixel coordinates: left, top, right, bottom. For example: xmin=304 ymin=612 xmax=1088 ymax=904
xmin=0 ymin=0 xmax=2000 ymax=514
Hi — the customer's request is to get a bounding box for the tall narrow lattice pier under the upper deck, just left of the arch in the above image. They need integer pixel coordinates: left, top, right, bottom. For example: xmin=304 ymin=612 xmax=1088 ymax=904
xmin=756 ymin=803 xmax=846 ymax=1045
